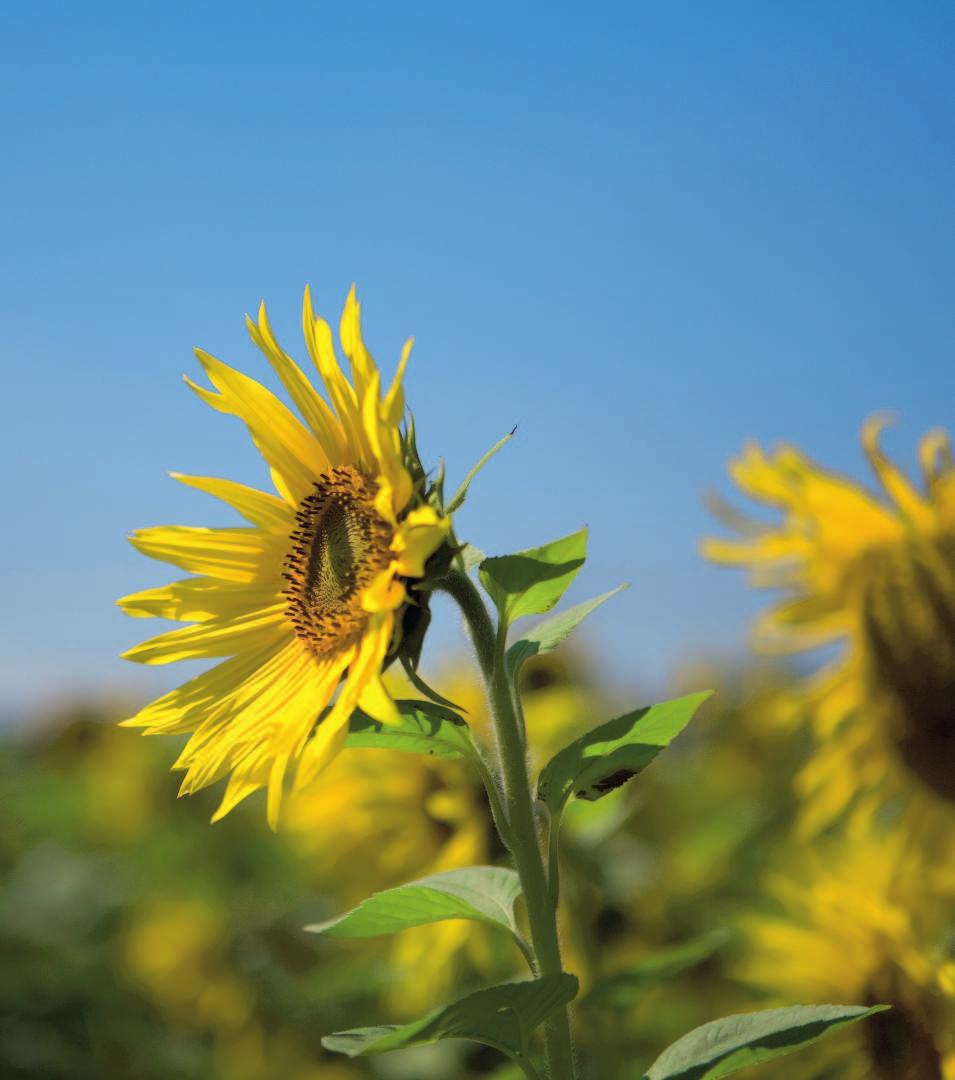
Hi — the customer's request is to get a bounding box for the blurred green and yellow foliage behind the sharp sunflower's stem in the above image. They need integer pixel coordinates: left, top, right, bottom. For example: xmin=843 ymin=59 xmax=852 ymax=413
xmin=0 ymin=653 xmax=951 ymax=1080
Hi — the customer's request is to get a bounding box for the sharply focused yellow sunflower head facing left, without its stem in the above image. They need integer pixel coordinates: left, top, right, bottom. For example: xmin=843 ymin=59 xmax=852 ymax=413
xmin=118 ymin=288 xmax=449 ymax=825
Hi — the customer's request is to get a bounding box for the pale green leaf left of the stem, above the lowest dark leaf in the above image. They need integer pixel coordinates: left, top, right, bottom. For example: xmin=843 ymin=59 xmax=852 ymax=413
xmin=305 ymin=866 xmax=521 ymax=937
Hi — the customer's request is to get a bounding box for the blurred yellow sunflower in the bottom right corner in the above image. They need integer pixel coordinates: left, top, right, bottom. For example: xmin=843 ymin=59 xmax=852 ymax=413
xmin=738 ymin=826 xmax=955 ymax=1080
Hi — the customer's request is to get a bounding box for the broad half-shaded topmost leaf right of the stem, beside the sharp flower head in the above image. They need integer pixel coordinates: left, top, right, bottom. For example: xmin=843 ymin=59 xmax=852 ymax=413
xmin=480 ymin=528 xmax=587 ymax=622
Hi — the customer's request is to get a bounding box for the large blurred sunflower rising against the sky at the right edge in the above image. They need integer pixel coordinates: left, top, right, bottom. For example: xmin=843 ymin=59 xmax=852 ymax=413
xmin=702 ymin=417 xmax=955 ymax=826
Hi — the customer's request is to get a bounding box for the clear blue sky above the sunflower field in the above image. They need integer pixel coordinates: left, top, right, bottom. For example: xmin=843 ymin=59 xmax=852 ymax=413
xmin=0 ymin=2 xmax=955 ymax=714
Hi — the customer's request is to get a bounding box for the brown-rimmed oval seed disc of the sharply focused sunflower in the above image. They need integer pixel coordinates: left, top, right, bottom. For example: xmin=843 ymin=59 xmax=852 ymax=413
xmin=284 ymin=465 xmax=392 ymax=656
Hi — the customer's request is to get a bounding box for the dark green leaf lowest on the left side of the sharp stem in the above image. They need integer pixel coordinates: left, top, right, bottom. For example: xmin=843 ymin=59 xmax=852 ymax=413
xmin=322 ymin=974 xmax=577 ymax=1057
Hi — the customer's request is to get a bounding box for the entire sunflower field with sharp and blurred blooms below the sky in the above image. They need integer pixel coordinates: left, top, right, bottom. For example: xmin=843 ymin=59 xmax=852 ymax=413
xmin=0 ymin=289 xmax=955 ymax=1080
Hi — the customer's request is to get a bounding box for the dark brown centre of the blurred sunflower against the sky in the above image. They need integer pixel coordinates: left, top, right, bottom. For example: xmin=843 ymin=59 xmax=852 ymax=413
xmin=857 ymin=537 xmax=955 ymax=800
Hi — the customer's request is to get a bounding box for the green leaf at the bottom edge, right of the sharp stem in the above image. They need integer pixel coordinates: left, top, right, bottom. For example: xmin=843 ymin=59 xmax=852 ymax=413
xmin=643 ymin=1005 xmax=888 ymax=1080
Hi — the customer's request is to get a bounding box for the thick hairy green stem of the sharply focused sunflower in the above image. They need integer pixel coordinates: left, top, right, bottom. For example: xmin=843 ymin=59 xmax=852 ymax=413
xmin=442 ymin=571 xmax=577 ymax=1080
